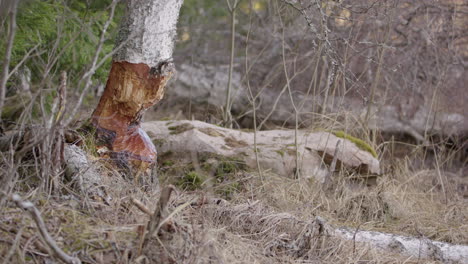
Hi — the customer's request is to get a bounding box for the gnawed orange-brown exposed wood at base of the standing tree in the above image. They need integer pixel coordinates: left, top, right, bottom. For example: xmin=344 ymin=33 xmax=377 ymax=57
xmin=92 ymin=61 xmax=172 ymax=174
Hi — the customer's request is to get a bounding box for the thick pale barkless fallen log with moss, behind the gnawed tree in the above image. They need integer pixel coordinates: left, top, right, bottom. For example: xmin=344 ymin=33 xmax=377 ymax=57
xmin=142 ymin=120 xmax=380 ymax=180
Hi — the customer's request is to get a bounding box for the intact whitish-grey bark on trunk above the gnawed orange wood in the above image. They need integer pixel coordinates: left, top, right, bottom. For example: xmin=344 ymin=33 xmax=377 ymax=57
xmin=114 ymin=0 xmax=183 ymax=67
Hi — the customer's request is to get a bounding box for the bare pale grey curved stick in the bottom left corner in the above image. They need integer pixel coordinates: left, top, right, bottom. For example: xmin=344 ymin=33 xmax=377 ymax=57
xmin=11 ymin=194 xmax=81 ymax=264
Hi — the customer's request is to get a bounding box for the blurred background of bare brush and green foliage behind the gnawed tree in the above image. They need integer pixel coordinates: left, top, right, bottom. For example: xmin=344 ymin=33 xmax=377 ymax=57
xmin=0 ymin=0 xmax=468 ymax=138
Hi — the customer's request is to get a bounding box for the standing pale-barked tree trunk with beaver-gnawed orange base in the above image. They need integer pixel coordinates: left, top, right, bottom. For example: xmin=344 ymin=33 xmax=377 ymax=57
xmin=92 ymin=0 xmax=183 ymax=176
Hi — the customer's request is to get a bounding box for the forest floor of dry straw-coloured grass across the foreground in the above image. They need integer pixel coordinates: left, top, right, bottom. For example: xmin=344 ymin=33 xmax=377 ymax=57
xmin=0 ymin=132 xmax=468 ymax=263
